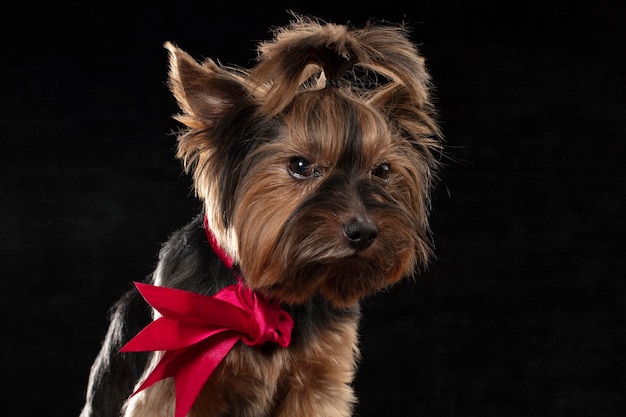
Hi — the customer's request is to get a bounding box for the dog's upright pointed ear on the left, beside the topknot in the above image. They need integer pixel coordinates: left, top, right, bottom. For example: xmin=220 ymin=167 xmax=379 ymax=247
xmin=164 ymin=42 xmax=248 ymax=129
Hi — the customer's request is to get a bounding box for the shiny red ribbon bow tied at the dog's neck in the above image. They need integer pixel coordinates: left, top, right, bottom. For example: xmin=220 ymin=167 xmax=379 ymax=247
xmin=121 ymin=223 xmax=294 ymax=417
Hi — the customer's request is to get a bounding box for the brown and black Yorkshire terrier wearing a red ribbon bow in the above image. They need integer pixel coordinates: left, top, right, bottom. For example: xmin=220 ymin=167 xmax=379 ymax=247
xmin=80 ymin=13 xmax=443 ymax=417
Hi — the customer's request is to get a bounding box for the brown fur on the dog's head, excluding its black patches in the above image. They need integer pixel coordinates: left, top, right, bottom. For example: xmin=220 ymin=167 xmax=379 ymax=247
xmin=167 ymin=18 xmax=440 ymax=305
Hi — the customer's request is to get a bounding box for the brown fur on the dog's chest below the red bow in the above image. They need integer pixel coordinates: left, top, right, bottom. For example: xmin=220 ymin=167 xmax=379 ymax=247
xmin=124 ymin=321 xmax=358 ymax=417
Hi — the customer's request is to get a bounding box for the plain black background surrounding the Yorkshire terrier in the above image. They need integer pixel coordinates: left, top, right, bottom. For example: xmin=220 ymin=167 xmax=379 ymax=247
xmin=0 ymin=0 xmax=626 ymax=417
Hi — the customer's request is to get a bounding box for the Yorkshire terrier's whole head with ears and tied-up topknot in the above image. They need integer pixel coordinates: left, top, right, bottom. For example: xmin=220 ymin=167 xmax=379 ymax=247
xmin=167 ymin=20 xmax=440 ymax=306
